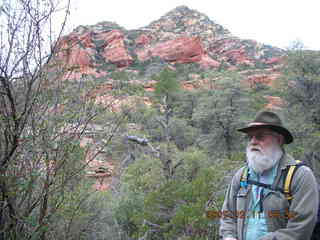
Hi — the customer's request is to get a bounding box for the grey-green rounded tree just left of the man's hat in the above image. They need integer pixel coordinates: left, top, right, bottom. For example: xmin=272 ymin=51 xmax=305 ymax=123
xmin=193 ymin=72 xmax=250 ymax=158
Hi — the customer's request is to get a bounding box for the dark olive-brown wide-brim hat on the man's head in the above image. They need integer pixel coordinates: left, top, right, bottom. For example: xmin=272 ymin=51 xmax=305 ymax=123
xmin=238 ymin=111 xmax=293 ymax=144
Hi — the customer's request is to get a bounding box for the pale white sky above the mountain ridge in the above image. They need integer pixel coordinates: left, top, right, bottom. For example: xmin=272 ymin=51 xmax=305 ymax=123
xmin=58 ymin=0 xmax=320 ymax=50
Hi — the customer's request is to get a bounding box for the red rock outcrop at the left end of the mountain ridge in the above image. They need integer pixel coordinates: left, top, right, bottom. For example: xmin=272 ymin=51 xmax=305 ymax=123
xmin=53 ymin=30 xmax=133 ymax=79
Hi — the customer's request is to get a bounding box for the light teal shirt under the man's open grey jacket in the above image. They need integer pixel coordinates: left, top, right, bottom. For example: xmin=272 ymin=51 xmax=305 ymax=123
xmin=245 ymin=164 xmax=278 ymax=240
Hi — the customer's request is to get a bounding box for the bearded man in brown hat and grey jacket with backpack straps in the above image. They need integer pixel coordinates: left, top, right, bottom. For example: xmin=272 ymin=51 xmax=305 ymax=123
xmin=220 ymin=111 xmax=319 ymax=240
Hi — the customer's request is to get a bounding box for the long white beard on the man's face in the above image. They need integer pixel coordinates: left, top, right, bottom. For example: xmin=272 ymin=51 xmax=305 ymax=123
xmin=246 ymin=143 xmax=283 ymax=174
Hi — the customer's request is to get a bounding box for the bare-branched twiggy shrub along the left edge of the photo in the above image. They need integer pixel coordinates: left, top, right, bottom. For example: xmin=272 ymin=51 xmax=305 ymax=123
xmin=0 ymin=0 xmax=127 ymax=240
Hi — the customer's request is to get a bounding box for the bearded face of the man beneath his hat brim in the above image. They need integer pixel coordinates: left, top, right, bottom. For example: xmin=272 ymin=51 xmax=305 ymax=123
xmin=246 ymin=129 xmax=283 ymax=173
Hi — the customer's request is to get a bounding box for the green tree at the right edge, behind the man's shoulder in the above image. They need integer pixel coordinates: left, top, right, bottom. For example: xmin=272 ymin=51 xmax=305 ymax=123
xmin=282 ymin=47 xmax=320 ymax=179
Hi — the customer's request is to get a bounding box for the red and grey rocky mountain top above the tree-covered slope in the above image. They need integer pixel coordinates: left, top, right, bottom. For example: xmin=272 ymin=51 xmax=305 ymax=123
xmin=56 ymin=6 xmax=284 ymax=78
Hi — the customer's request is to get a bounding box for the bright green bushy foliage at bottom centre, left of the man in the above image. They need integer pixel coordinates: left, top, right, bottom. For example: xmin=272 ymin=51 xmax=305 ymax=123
xmin=119 ymin=148 xmax=243 ymax=239
